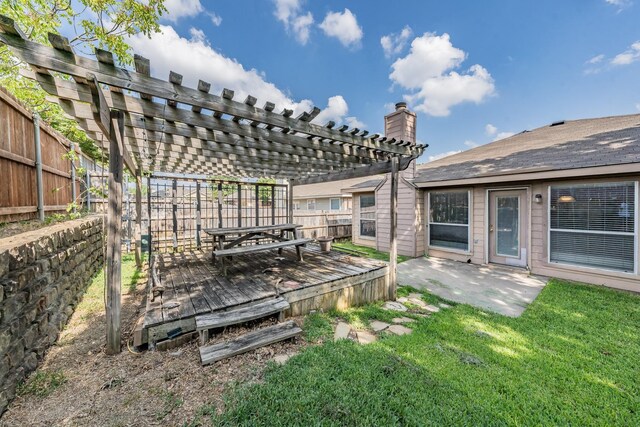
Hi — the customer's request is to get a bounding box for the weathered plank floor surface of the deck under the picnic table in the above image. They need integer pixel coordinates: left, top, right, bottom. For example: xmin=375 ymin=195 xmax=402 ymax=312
xmin=144 ymin=245 xmax=386 ymax=327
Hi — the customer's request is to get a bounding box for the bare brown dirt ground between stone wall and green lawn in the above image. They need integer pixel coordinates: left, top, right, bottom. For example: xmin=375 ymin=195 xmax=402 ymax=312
xmin=0 ymin=262 xmax=307 ymax=426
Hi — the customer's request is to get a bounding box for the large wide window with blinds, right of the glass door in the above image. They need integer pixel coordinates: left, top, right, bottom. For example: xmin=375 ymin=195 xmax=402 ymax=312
xmin=549 ymin=182 xmax=638 ymax=272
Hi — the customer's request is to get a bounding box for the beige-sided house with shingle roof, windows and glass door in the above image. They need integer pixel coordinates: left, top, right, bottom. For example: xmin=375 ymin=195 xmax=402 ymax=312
xmin=346 ymin=108 xmax=640 ymax=291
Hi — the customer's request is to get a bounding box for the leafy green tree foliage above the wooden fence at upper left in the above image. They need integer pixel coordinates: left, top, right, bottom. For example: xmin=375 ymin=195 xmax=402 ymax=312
xmin=0 ymin=0 xmax=166 ymax=159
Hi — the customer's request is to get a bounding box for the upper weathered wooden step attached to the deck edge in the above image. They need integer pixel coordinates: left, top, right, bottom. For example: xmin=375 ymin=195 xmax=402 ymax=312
xmin=196 ymin=297 xmax=289 ymax=332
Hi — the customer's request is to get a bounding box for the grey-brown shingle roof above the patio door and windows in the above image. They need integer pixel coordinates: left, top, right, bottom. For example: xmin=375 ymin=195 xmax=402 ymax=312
xmin=414 ymin=114 xmax=640 ymax=183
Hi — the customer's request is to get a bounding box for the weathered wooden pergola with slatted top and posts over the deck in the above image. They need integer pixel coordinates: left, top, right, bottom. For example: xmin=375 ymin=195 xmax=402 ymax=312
xmin=0 ymin=15 xmax=425 ymax=353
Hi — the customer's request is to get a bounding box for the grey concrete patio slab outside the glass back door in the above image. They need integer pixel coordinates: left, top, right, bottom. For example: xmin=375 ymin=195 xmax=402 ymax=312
xmin=398 ymin=257 xmax=547 ymax=317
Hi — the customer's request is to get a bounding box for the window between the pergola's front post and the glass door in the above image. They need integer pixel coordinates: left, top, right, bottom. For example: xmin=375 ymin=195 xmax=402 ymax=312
xmin=429 ymin=191 xmax=470 ymax=251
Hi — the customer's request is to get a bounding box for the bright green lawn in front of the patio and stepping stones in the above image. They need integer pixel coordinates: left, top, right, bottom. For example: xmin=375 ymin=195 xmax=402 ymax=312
xmin=210 ymin=280 xmax=640 ymax=426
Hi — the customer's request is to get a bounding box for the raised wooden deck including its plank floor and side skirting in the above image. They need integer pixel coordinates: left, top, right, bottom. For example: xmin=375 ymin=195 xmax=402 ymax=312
xmin=139 ymin=245 xmax=388 ymax=343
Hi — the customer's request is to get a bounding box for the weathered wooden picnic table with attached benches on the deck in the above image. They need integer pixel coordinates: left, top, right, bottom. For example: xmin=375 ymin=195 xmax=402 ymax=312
xmin=203 ymin=224 xmax=312 ymax=276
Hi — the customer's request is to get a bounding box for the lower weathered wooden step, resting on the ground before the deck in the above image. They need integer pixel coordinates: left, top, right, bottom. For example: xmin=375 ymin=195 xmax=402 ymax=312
xmin=200 ymin=320 xmax=302 ymax=366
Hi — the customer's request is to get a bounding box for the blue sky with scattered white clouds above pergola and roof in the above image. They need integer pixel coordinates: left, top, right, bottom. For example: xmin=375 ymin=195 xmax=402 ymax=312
xmin=122 ymin=0 xmax=640 ymax=161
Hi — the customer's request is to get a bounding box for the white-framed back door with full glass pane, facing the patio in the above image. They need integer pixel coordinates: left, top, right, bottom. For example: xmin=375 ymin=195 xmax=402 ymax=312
xmin=488 ymin=189 xmax=529 ymax=267
